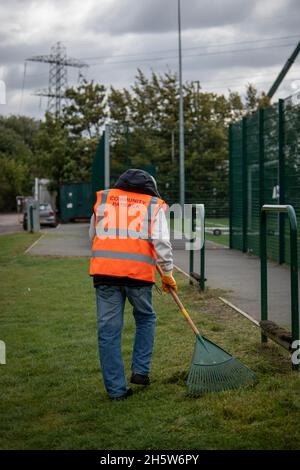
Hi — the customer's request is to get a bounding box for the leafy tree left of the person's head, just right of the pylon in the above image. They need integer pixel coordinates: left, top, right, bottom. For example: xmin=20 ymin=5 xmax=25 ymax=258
xmin=36 ymin=81 xmax=107 ymax=186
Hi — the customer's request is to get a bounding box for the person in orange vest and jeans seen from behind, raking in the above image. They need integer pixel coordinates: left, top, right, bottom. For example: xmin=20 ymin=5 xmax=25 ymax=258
xmin=90 ymin=169 xmax=177 ymax=400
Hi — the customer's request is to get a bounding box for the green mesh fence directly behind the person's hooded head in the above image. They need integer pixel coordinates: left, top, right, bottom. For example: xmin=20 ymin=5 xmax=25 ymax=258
xmin=92 ymin=125 xmax=229 ymax=217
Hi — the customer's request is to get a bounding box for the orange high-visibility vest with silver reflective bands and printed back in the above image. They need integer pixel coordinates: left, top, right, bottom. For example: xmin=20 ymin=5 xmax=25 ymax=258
xmin=90 ymin=189 xmax=166 ymax=282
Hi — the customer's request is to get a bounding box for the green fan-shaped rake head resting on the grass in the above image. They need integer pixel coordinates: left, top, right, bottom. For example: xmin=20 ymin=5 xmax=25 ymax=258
xmin=187 ymin=335 xmax=256 ymax=396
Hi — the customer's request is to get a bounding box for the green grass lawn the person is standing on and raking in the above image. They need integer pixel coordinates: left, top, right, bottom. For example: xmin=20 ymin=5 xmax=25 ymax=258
xmin=0 ymin=233 xmax=300 ymax=450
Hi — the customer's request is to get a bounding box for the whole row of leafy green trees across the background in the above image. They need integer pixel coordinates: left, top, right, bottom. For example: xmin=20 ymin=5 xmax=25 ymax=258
xmin=0 ymin=70 xmax=269 ymax=215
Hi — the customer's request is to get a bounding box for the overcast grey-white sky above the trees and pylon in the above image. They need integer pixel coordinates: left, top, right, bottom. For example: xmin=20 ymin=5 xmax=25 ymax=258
xmin=0 ymin=0 xmax=300 ymax=117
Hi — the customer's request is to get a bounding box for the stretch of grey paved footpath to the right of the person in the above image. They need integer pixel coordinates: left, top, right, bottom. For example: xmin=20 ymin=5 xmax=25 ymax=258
xmin=173 ymin=235 xmax=300 ymax=327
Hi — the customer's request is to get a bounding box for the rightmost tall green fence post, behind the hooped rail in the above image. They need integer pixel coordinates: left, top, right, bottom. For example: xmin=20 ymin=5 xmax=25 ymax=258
xmin=278 ymin=99 xmax=285 ymax=264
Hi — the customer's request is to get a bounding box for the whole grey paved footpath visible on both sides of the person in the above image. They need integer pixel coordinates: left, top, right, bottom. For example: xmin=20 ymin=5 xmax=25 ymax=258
xmin=28 ymin=223 xmax=300 ymax=327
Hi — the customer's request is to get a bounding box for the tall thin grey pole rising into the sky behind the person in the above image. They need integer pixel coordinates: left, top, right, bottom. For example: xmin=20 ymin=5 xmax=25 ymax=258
xmin=178 ymin=0 xmax=185 ymax=209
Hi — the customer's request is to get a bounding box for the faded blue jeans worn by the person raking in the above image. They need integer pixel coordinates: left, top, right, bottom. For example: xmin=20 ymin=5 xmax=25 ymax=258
xmin=96 ymin=285 xmax=156 ymax=397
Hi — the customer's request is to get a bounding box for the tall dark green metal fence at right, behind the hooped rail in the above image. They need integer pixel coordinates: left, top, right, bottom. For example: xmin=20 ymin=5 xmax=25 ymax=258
xmin=229 ymin=94 xmax=300 ymax=263
